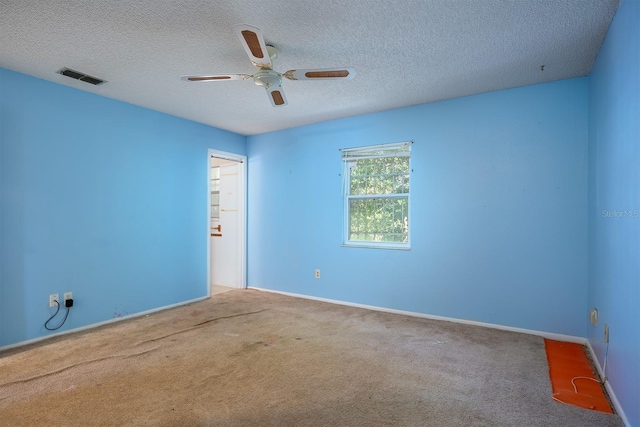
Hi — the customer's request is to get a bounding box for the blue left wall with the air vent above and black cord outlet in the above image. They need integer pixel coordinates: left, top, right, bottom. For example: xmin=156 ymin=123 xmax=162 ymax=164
xmin=0 ymin=69 xmax=246 ymax=346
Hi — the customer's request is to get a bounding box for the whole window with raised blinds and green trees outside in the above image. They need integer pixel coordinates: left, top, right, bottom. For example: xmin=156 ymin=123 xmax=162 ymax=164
xmin=342 ymin=142 xmax=411 ymax=249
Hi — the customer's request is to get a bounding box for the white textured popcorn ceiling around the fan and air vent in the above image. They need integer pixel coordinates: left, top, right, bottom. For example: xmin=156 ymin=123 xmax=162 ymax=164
xmin=0 ymin=0 xmax=619 ymax=135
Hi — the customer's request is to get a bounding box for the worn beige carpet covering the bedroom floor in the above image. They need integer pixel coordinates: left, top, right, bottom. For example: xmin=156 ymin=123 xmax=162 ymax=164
xmin=0 ymin=290 xmax=623 ymax=427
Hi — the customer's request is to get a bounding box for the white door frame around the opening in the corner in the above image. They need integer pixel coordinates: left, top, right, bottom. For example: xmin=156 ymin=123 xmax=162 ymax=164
xmin=206 ymin=148 xmax=247 ymax=297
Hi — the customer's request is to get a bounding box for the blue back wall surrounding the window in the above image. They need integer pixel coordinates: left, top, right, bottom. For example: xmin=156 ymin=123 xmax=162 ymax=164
xmin=247 ymin=78 xmax=588 ymax=337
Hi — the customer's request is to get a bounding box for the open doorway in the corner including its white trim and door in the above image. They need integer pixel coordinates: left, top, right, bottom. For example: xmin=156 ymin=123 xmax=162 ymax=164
xmin=207 ymin=150 xmax=247 ymax=295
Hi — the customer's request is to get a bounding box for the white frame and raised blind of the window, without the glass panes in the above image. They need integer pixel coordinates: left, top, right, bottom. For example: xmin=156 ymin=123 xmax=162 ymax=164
xmin=340 ymin=141 xmax=413 ymax=250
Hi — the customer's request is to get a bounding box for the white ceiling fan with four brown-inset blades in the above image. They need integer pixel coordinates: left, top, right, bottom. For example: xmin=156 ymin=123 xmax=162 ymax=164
xmin=182 ymin=24 xmax=356 ymax=107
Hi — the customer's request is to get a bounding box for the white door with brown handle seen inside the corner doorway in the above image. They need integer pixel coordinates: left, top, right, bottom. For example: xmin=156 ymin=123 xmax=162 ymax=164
xmin=210 ymin=157 xmax=244 ymax=288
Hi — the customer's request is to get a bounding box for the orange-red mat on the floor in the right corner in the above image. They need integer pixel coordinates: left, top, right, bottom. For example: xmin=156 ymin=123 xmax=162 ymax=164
xmin=544 ymin=339 xmax=613 ymax=414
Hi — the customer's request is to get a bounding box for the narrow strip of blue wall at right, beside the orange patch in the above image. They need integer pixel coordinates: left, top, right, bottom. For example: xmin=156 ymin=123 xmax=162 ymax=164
xmin=588 ymin=0 xmax=640 ymax=426
